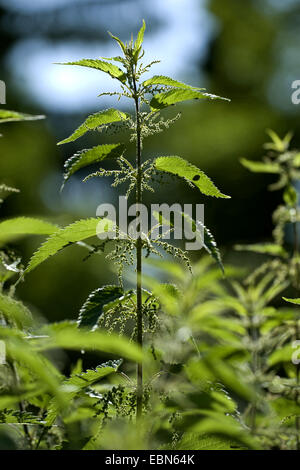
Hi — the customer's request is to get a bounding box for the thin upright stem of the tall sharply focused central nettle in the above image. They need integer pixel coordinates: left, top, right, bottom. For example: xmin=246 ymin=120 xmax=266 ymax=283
xmin=132 ymin=66 xmax=143 ymax=420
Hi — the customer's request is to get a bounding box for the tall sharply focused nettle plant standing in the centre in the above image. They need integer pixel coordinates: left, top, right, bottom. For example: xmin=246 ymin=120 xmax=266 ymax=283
xmin=42 ymin=22 xmax=229 ymax=417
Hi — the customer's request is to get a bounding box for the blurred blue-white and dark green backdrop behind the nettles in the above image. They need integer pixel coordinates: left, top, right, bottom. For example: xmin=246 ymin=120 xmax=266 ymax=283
xmin=0 ymin=0 xmax=300 ymax=321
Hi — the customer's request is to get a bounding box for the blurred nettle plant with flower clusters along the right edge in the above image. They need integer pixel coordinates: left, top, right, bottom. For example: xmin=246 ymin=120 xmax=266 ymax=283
xmin=231 ymin=131 xmax=300 ymax=450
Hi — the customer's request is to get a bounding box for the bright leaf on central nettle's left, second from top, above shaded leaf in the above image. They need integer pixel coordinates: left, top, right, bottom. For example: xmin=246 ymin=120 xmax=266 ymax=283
xmin=57 ymin=108 xmax=128 ymax=145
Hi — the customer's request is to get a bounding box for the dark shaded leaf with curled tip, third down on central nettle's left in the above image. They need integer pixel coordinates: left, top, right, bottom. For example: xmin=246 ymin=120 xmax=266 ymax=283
xmin=64 ymin=144 xmax=125 ymax=187
